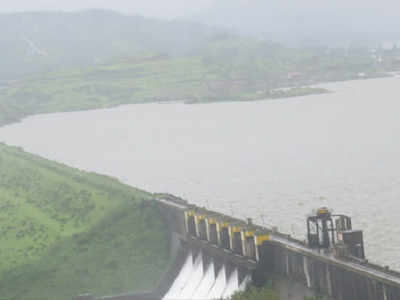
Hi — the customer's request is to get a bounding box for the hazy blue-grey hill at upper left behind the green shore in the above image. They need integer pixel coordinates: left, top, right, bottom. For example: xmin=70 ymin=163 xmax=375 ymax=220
xmin=0 ymin=10 xmax=222 ymax=82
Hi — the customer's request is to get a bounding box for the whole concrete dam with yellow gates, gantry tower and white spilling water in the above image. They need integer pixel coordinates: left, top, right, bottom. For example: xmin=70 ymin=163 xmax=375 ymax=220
xmin=77 ymin=194 xmax=400 ymax=300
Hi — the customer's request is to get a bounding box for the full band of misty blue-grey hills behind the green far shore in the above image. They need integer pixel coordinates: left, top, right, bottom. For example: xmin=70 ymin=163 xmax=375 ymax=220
xmin=0 ymin=5 xmax=400 ymax=83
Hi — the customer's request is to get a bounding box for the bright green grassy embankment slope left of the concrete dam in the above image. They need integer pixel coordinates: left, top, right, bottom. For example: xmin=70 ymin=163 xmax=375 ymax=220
xmin=0 ymin=144 xmax=168 ymax=300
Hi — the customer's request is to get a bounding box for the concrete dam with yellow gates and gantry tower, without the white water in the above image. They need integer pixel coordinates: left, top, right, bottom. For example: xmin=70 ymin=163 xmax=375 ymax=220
xmin=157 ymin=195 xmax=400 ymax=300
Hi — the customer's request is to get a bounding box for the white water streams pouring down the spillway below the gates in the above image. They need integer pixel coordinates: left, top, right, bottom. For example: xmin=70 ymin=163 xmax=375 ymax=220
xmin=163 ymin=252 xmax=250 ymax=300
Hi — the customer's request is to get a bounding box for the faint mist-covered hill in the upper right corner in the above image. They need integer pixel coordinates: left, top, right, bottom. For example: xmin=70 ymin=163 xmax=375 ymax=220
xmin=193 ymin=0 xmax=400 ymax=46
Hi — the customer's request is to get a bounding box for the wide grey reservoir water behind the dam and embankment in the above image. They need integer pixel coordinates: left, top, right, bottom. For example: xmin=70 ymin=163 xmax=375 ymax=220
xmin=0 ymin=77 xmax=400 ymax=269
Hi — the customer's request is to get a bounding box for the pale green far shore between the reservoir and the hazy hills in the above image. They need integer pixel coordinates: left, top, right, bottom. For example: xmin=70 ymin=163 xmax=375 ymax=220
xmin=0 ymin=35 xmax=400 ymax=125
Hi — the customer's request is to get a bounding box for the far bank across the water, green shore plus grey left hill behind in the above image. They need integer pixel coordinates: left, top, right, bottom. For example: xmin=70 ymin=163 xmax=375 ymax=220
xmin=0 ymin=11 xmax=400 ymax=125
